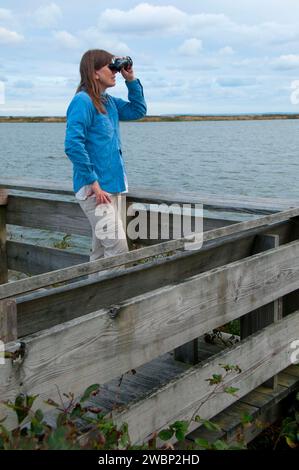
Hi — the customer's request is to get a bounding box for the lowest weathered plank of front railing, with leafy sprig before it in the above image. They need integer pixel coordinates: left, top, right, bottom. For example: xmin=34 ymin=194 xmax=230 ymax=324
xmin=114 ymin=312 xmax=299 ymax=442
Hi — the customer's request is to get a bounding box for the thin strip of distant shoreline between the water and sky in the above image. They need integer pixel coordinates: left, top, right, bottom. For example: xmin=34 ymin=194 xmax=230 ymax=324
xmin=0 ymin=113 xmax=299 ymax=123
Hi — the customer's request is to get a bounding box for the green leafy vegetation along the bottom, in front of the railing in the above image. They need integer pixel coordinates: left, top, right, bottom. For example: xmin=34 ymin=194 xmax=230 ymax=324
xmin=0 ymin=364 xmax=299 ymax=450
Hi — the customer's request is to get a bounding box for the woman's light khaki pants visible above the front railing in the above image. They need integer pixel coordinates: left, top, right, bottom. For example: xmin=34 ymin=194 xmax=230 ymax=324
xmin=79 ymin=194 xmax=128 ymax=261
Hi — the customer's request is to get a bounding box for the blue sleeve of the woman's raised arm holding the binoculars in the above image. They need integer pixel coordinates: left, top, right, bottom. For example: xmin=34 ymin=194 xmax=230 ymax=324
xmin=112 ymin=79 xmax=146 ymax=121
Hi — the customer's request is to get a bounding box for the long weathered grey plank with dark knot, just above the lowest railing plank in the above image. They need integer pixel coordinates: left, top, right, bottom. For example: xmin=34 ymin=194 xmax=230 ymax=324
xmin=2 ymin=242 xmax=299 ymax=404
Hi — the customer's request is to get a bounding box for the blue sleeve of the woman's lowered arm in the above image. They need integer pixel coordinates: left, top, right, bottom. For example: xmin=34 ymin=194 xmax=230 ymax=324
xmin=65 ymin=93 xmax=98 ymax=184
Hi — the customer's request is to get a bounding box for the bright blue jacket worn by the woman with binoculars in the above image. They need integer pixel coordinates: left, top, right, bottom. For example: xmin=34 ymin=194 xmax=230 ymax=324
xmin=65 ymin=79 xmax=146 ymax=193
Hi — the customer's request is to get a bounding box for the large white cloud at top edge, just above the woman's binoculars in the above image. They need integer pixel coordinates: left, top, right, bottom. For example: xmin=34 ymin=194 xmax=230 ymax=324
xmin=98 ymin=3 xmax=188 ymax=34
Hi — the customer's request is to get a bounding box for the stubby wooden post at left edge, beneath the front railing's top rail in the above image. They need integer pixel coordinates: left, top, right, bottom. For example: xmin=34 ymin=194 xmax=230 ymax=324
xmin=0 ymin=299 xmax=18 ymax=343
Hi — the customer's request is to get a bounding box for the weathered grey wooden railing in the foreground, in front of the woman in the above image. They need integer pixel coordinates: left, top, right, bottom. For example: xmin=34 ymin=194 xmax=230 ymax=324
xmin=0 ymin=178 xmax=299 ymax=442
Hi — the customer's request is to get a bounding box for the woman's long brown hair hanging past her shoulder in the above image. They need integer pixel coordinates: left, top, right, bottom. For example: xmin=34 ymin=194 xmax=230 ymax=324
xmin=77 ymin=49 xmax=114 ymax=114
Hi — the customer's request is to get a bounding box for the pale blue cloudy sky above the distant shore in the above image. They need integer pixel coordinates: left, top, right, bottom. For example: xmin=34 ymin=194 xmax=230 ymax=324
xmin=0 ymin=0 xmax=299 ymax=116
